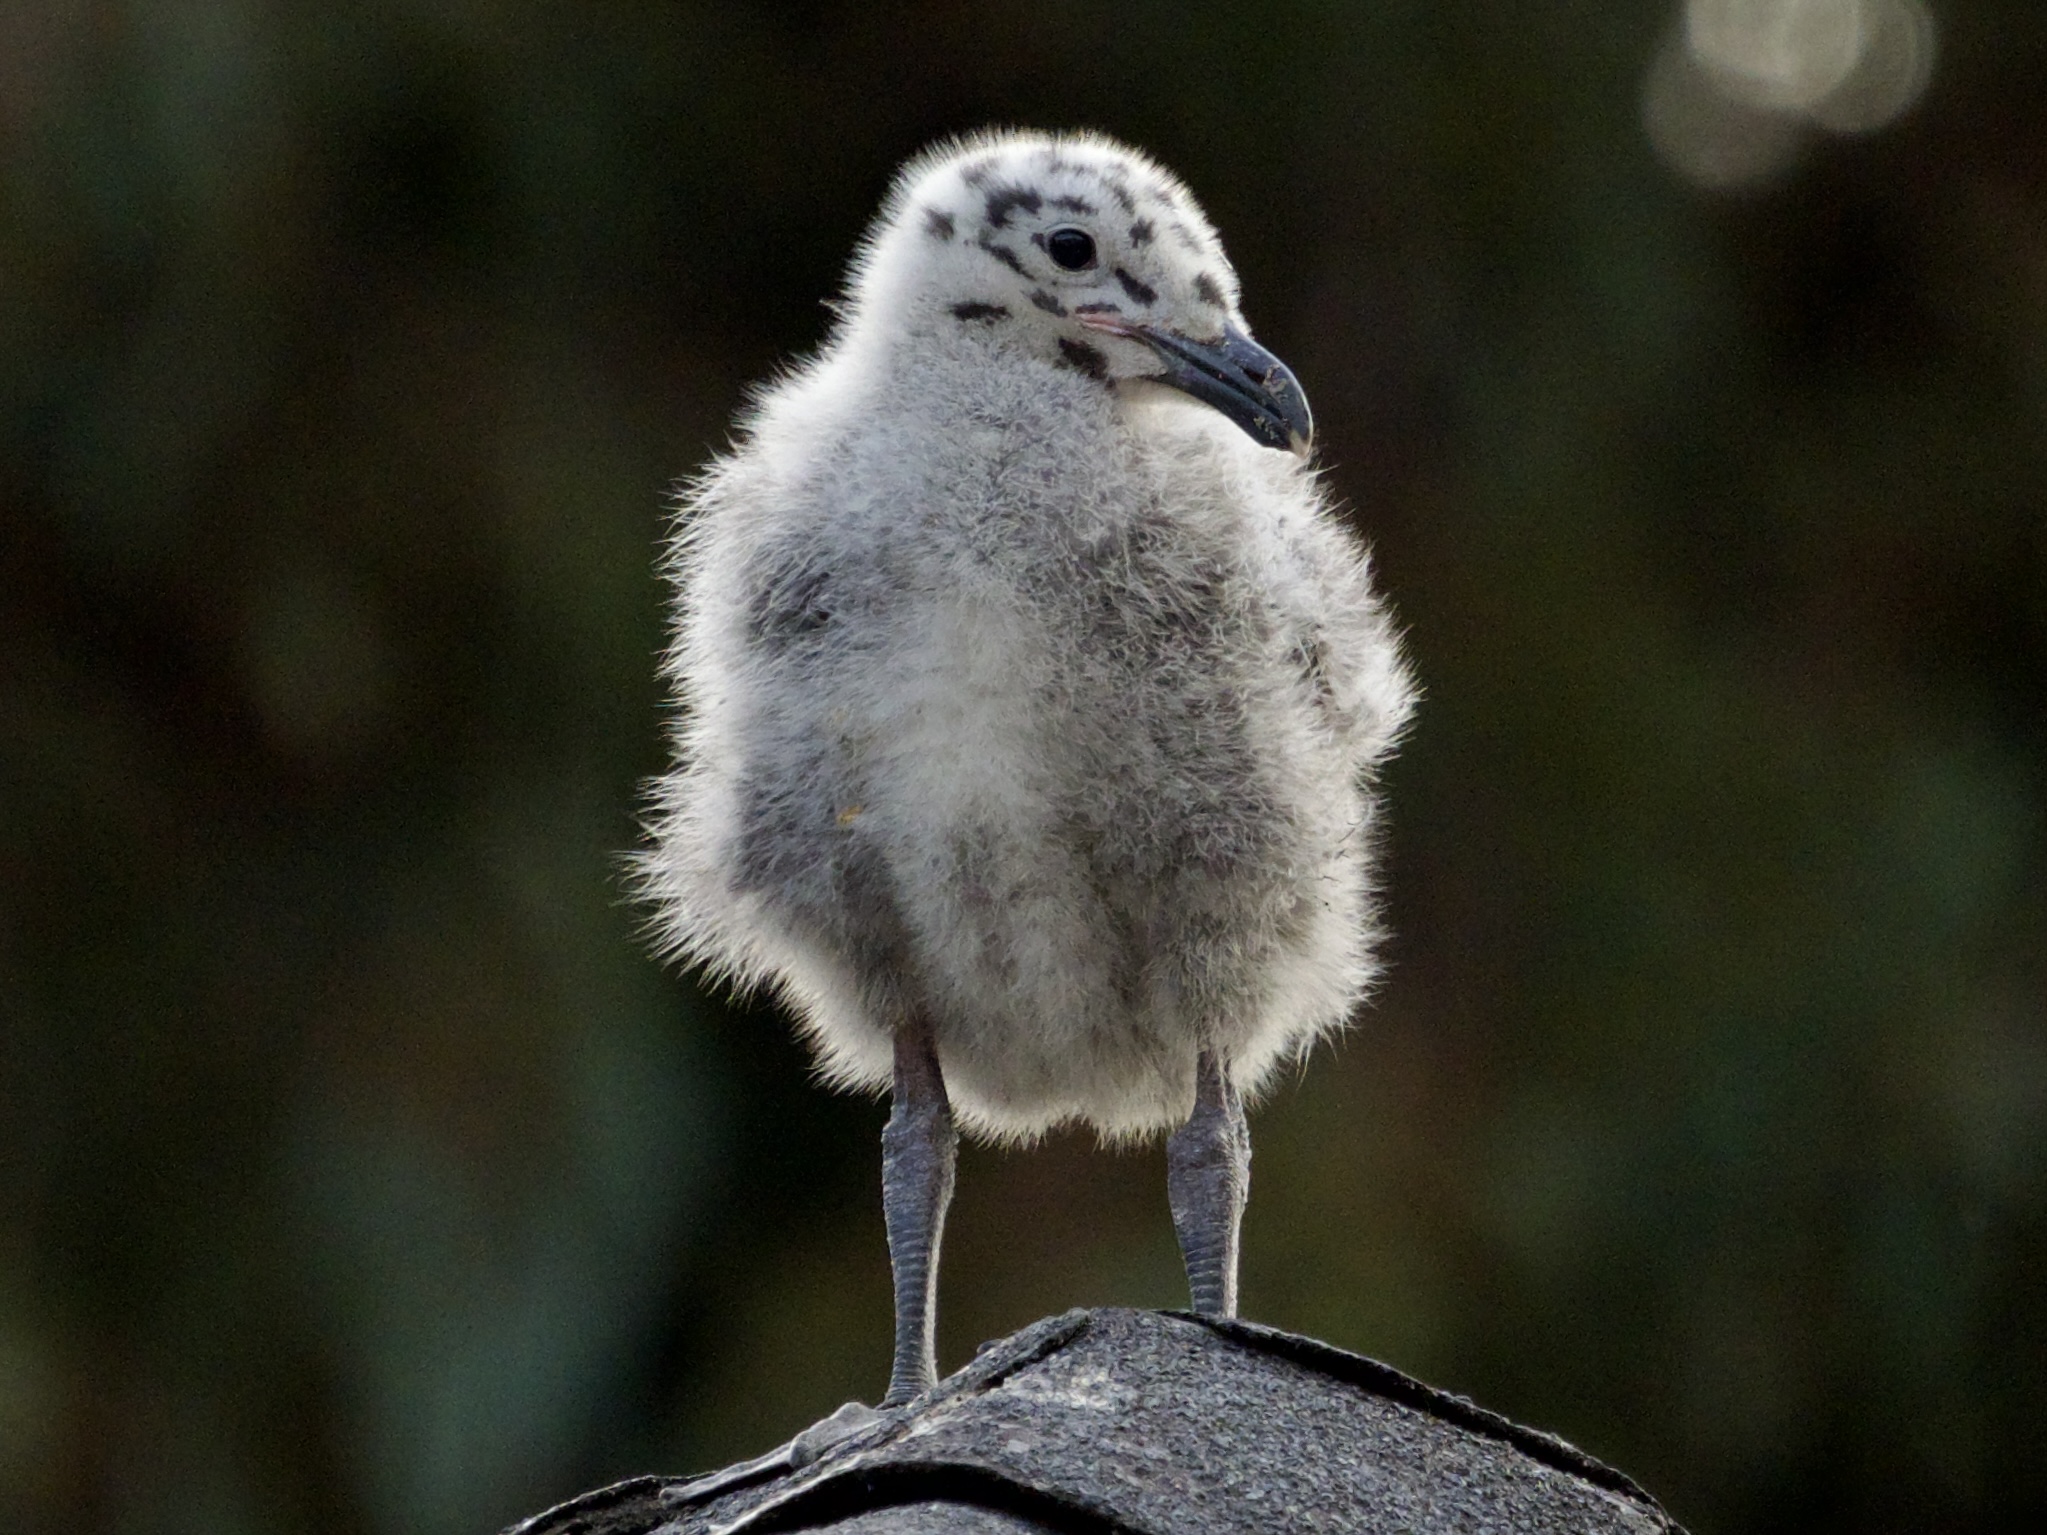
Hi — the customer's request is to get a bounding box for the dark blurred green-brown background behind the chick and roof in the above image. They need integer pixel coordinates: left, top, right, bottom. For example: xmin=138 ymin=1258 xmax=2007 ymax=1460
xmin=0 ymin=0 xmax=2047 ymax=1535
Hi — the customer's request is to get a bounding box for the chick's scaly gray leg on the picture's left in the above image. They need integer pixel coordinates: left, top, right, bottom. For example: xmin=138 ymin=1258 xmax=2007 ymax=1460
xmin=882 ymin=1019 xmax=958 ymax=1406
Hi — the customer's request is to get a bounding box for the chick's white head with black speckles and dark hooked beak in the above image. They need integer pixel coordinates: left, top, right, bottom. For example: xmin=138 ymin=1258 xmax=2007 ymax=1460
xmin=843 ymin=133 xmax=1308 ymax=450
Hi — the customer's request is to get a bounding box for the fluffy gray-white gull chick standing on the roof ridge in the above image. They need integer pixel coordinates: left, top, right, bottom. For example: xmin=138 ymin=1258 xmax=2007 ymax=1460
xmin=639 ymin=133 xmax=1412 ymax=1404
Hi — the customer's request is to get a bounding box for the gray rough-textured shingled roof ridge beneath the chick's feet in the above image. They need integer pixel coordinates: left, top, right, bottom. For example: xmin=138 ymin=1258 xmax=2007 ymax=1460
xmin=516 ymin=1310 xmax=1676 ymax=1535
